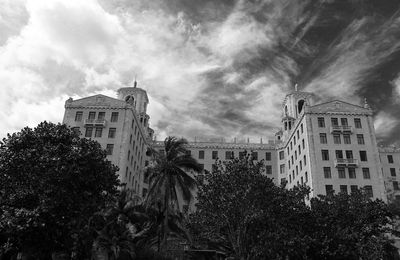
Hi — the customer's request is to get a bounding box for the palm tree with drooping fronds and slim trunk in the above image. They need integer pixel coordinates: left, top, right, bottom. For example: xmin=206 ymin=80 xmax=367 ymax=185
xmin=146 ymin=136 xmax=201 ymax=251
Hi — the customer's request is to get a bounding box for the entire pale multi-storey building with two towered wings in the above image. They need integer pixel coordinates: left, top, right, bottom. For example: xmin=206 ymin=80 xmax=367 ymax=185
xmin=64 ymin=82 xmax=400 ymax=204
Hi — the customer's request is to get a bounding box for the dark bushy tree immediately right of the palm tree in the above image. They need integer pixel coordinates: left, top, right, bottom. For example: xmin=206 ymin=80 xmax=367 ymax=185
xmin=190 ymin=155 xmax=310 ymax=259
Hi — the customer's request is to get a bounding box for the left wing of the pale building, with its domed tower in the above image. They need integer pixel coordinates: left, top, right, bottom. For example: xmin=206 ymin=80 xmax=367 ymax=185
xmin=63 ymin=81 xmax=154 ymax=196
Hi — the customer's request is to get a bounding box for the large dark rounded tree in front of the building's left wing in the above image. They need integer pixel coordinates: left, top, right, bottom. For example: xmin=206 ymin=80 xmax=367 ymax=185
xmin=0 ymin=122 xmax=119 ymax=254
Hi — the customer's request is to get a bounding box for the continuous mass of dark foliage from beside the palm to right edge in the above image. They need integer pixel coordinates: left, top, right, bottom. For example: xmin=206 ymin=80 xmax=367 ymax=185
xmin=190 ymin=152 xmax=393 ymax=259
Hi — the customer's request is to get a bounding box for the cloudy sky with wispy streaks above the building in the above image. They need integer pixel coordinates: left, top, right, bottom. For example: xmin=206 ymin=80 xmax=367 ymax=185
xmin=0 ymin=0 xmax=400 ymax=146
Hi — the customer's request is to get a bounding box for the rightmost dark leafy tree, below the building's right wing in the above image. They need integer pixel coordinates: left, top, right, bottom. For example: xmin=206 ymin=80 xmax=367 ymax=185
xmin=309 ymin=191 xmax=394 ymax=259
